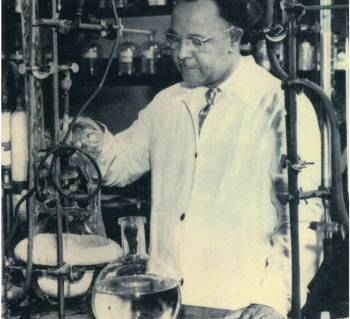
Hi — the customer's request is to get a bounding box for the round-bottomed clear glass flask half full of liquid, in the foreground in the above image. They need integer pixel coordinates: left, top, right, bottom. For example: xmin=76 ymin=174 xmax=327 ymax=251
xmin=92 ymin=216 xmax=181 ymax=319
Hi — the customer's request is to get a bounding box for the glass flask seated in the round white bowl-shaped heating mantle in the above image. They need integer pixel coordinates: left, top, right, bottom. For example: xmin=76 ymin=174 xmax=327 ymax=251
xmin=14 ymin=138 xmax=121 ymax=298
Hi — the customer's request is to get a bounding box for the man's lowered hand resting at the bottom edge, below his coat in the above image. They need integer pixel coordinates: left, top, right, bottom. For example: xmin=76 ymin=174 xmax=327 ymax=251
xmin=224 ymin=304 xmax=284 ymax=319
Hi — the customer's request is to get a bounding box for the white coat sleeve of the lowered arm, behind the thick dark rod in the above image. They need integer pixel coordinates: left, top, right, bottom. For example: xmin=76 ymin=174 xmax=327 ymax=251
xmin=252 ymin=95 xmax=323 ymax=317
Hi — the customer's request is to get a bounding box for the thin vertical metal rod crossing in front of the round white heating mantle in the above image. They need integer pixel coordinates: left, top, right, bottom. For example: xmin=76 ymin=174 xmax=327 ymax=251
xmin=51 ymin=0 xmax=65 ymax=319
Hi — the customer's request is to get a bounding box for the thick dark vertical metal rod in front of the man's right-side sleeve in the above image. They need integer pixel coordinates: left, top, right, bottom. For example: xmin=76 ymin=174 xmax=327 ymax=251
xmin=284 ymin=7 xmax=301 ymax=319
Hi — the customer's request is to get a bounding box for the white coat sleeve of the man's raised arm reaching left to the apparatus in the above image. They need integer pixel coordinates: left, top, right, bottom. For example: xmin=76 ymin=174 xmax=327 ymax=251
xmin=97 ymin=103 xmax=152 ymax=187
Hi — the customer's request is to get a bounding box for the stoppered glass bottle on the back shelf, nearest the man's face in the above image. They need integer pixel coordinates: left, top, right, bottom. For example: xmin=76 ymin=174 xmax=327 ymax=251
xmin=141 ymin=34 xmax=160 ymax=74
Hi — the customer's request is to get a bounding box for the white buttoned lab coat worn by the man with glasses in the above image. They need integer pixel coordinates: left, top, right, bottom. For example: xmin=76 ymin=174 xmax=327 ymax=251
xmin=98 ymin=57 xmax=322 ymax=315
